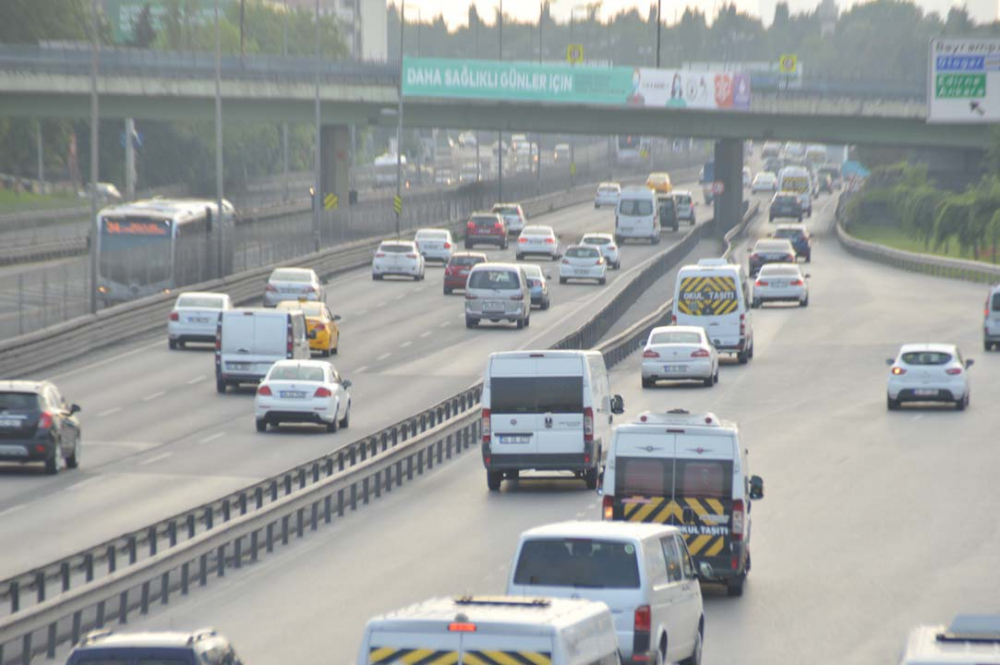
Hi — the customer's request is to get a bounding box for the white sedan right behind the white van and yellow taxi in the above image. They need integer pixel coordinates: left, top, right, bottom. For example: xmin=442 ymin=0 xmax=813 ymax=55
xmin=254 ymin=360 xmax=351 ymax=432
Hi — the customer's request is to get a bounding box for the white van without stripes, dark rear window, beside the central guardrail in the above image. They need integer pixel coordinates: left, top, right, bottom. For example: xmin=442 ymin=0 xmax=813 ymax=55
xmin=482 ymin=351 xmax=624 ymax=491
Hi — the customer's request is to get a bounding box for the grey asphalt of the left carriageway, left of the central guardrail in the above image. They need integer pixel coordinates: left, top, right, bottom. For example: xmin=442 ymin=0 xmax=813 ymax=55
xmin=0 ymin=178 xmax=709 ymax=577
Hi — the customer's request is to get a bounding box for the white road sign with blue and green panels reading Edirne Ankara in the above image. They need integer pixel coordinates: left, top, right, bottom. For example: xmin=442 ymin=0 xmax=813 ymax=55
xmin=927 ymin=39 xmax=1000 ymax=123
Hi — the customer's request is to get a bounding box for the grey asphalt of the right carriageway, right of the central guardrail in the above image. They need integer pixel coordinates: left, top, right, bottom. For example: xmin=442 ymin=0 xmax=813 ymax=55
xmin=99 ymin=188 xmax=1000 ymax=665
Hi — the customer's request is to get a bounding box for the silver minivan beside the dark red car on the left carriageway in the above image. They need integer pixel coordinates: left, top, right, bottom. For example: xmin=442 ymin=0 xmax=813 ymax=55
xmin=465 ymin=263 xmax=531 ymax=328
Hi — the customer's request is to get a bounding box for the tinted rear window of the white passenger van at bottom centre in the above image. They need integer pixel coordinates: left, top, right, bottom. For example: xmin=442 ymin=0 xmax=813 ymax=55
xmin=514 ymin=538 xmax=639 ymax=589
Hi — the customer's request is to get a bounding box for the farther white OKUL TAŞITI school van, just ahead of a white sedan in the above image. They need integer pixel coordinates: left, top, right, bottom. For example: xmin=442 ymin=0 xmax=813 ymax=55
xmin=673 ymin=259 xmax=753 ymax=364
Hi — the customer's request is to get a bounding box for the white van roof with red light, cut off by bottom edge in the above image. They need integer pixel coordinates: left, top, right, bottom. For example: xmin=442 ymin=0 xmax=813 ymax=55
xmin=357 ymin=596 xmax=618 ymax=665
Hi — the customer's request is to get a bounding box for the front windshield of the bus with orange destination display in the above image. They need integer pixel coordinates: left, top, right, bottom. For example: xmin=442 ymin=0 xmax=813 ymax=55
xmin=100 ymin=217 xmax=173 ymax=286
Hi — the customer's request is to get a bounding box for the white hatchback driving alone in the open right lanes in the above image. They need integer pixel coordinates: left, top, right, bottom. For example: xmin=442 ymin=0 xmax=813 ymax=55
xmin=885 ymin=344 xmax=973 ymax=411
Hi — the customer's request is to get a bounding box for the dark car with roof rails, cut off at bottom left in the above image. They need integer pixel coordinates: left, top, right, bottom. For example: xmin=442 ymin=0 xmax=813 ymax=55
xmin=66 ymin=628 xmax=242 ymax=665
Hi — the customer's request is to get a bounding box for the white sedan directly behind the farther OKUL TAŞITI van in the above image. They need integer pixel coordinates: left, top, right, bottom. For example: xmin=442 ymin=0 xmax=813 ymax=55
xmin=642 ymin=326 xmax=719 ymax=388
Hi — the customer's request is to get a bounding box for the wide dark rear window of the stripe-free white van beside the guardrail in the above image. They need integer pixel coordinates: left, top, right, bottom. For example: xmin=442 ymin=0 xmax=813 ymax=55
xmin=490 ymin=376 xmax=583 ymax=413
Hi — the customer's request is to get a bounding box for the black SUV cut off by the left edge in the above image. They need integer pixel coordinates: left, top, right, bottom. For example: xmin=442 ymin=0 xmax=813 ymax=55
xmin=0 ymin=381 xmax=80 ymax=474
